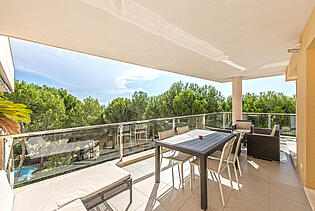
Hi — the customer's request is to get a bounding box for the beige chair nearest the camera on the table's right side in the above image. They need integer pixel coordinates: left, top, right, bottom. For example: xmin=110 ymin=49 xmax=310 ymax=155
xmin=190 ymin=137 xmax=236 ymax=206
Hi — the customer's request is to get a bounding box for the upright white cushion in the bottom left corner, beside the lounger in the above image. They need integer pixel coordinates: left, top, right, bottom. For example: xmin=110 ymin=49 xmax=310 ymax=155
xmin=0 ymin=170 xmax=14 ymax=211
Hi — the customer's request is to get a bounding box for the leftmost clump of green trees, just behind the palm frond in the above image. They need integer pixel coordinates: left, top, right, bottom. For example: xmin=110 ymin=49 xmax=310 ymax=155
xmin=3 ymin=81 xmax=103 ymax=132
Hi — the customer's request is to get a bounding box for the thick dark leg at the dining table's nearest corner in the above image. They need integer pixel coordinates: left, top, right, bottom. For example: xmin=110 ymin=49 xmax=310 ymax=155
xmin=200 ymin=156 xmax=208 ymax=210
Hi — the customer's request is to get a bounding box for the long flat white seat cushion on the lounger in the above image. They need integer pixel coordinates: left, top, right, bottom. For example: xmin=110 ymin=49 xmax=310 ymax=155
xmin=14 ymin=163 xmax=130 ymax=211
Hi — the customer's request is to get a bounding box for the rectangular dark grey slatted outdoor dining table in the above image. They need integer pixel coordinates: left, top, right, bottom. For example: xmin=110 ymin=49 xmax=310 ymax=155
xmin=155 ymin=129 xmax=235 ymax=210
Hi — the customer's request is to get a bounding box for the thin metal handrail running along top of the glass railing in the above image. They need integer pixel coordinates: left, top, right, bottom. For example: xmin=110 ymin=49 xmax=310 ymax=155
xmin=0 ymin=112 xmax=295 ymax=141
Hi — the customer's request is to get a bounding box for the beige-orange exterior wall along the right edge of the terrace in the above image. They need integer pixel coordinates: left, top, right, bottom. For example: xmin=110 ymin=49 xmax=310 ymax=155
xmin=286 ymin=8 xmax=315 ymax=188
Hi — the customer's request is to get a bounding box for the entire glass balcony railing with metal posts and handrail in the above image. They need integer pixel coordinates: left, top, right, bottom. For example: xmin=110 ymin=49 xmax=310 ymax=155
xmin=0 ymin=112 xmax=295 ymax=187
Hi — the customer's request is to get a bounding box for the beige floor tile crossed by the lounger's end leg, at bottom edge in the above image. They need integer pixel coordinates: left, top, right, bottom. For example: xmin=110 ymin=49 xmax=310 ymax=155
xmin=108 ymin=188 xmax=149 ymax=211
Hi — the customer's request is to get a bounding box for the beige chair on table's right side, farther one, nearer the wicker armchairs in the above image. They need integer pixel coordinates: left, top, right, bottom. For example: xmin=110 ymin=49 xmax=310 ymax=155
xmin=209 ymin=133 xmax=244 ymax=190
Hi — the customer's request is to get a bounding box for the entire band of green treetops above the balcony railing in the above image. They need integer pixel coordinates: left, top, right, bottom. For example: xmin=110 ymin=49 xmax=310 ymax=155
xmin=2 ymin=81 xmax=295 ymax=131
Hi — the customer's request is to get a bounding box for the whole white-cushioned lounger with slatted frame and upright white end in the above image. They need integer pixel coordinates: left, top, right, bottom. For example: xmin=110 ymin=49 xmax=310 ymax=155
xmin=0 ymin=163 xmax=132 ymax=211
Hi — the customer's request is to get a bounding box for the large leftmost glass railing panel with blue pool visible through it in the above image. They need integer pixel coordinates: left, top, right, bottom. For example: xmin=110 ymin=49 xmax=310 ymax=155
xmin=10 ymin=127 xmax=120 ymax=187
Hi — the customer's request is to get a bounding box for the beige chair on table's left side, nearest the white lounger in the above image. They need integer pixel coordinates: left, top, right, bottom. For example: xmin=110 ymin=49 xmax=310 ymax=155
xmin=158 ymin=129 xmax=192 ymax=188
